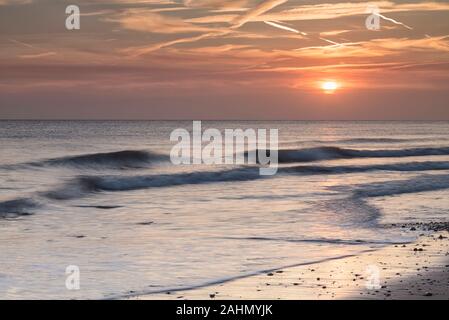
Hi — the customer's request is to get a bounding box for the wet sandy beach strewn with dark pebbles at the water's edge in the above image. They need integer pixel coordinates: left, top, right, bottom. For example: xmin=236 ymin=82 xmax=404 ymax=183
xmin=130 ymin=223 xmax=449 ymax=300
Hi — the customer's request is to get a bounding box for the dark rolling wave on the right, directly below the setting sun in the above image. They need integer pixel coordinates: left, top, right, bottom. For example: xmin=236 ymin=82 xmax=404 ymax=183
xmin=272 ymin=147 xmax=449 ymax=163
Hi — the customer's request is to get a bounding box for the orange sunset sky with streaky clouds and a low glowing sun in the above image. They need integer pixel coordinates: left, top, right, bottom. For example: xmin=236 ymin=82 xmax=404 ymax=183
xmin=0 ymin=0 xmax=449 ymax=120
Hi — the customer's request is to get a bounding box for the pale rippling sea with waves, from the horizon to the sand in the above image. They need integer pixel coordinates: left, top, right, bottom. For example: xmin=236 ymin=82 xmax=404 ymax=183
xmin=0 ymin=121 xmax=449 ymax=299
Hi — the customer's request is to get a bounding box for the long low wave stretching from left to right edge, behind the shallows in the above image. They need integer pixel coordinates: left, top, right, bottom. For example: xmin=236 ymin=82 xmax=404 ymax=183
xmin=44 ymin=161 xmax=449 ymax=200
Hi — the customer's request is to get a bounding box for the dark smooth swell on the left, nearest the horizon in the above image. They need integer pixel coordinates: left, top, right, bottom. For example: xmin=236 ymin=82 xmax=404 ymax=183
xmin=2 ymin=150 xmax=168 ymax=169
